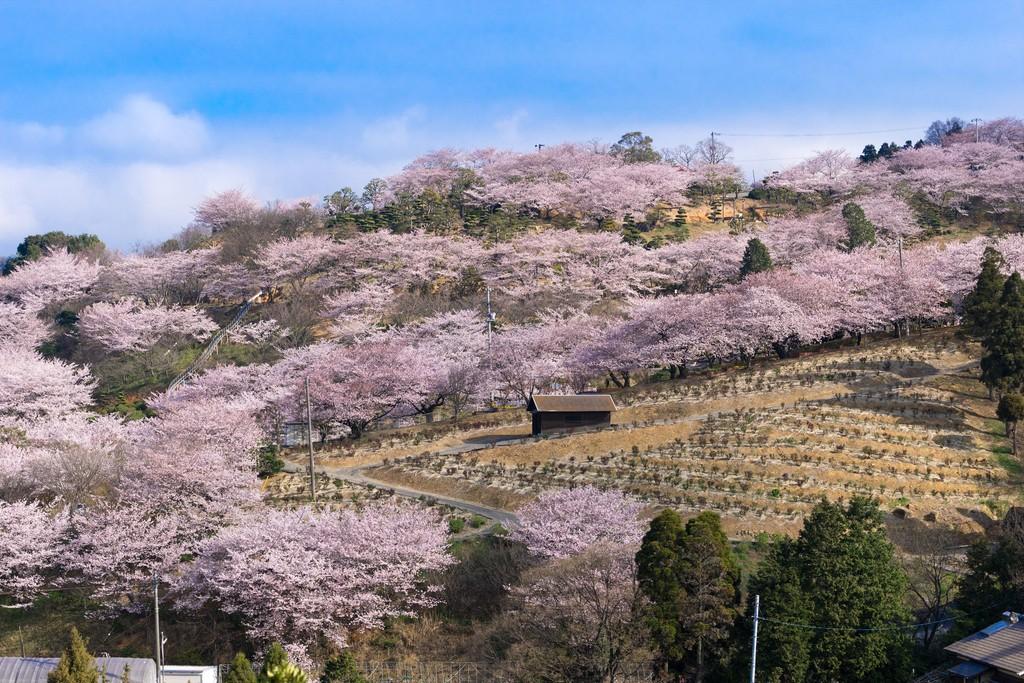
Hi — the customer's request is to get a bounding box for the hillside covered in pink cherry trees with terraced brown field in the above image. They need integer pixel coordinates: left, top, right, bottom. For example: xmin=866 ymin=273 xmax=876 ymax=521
xmin=0 ymin=120 xmax=1024 ymax=683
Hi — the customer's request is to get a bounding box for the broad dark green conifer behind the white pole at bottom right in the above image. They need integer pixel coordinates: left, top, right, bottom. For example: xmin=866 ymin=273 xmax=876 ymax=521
xmin=750 ymin=498 xmax=911 ymax=683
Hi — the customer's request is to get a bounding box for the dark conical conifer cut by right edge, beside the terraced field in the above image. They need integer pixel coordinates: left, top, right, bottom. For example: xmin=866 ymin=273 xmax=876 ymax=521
xmin=981 ymin=272 xmax=1024 ymax=392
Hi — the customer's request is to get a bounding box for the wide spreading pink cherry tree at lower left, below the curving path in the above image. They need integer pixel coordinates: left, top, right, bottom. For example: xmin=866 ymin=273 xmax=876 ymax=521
xmin=177 ymin=504 xmax=454 ymax=663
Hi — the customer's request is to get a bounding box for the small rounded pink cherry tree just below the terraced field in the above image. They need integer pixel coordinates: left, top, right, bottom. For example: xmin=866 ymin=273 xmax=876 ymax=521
xmin=512 ymin=486 xmax=643 ymax=558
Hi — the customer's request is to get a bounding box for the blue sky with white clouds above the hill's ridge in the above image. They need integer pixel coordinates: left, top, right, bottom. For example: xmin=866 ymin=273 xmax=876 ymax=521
xmin=0 ymin=0 xmax=1024 ymax=253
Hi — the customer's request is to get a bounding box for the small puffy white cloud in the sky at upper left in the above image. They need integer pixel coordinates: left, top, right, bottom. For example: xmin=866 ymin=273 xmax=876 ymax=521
xmin=81 ymin=94 xmax=210 ymax=159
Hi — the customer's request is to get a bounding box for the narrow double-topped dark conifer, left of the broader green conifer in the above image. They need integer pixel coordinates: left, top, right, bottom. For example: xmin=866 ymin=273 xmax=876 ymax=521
xmin=637 ymin=510 xmax=740 ymax=683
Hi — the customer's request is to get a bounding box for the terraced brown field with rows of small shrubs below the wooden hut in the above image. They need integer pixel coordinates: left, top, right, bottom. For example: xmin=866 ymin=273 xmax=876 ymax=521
xmin=373 ymin=335 xmax=1015 ymax=535
